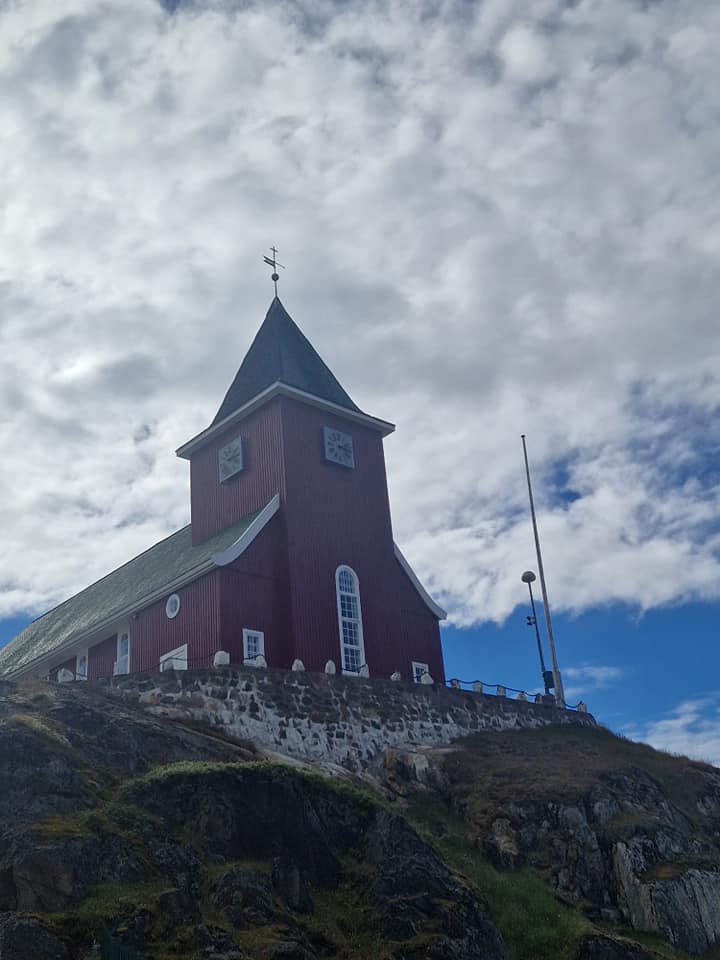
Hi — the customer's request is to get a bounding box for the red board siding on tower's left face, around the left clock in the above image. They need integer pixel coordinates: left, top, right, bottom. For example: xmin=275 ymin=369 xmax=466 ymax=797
xmin=190 ymin=399 xmax=284 ymax=543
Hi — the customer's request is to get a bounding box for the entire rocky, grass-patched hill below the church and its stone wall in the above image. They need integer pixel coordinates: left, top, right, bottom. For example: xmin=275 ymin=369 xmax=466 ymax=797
xmin=0 ymin=677 xmax=720 ymax=960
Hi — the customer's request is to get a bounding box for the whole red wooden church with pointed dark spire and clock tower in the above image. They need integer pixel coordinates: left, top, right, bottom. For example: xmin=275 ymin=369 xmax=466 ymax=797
xmin=0 ymin=297 xmax=445 ymax=680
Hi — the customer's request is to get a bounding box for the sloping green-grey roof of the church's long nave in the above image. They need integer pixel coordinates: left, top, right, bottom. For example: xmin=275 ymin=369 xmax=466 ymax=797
xmin=0 ymin=511 xmax=259 ymax=676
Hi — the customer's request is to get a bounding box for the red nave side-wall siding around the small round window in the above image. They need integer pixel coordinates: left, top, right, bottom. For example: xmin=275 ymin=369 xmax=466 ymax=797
xmin=130 ymin=570 xmax=221 ymax=673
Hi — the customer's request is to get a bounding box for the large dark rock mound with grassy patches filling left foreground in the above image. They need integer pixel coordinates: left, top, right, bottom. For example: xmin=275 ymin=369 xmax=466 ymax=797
xmin=0 ymin=689 xmax=506 ymax=960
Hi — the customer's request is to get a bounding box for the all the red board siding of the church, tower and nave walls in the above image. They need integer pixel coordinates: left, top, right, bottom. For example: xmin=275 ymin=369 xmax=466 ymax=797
xmin=81 ymin=386 xmax=444 ymax=680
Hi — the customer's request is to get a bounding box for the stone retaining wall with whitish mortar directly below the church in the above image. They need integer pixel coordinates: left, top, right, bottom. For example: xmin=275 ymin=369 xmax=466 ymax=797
xmin=99 ymin=667 xmax=595 ymax=768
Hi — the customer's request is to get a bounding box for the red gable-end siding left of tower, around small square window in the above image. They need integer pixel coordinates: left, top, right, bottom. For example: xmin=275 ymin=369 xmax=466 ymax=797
xmin=221 ymin=512 xmax=294 ymax=667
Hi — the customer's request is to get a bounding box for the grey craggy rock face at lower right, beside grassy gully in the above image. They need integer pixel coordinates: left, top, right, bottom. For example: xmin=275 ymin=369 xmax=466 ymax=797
xmin=478 ymin=795 xmax=720 ymax=953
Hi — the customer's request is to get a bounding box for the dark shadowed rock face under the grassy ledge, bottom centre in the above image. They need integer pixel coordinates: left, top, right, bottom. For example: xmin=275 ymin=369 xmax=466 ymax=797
xmin=125 ymin=767 xmax=505 ymax=960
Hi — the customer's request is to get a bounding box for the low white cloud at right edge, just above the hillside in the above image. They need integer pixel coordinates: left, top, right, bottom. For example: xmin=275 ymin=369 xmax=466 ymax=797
xmin=625 ymin=694 xmax=720 ymax=767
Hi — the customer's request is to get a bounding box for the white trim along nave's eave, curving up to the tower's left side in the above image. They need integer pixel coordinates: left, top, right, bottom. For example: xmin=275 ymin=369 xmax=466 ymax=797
xmin=5 ymin=494 xmax=280 ymax=679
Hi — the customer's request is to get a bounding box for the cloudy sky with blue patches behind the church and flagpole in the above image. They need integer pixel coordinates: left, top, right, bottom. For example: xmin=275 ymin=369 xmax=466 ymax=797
xmin=0 ymin=0 xmax=720 ymax=762
